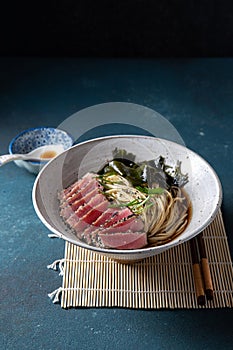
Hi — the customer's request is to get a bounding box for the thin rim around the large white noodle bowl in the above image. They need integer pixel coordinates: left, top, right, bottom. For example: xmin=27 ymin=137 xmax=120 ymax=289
xmin=32 ymin=135 xmax=223 ymax=256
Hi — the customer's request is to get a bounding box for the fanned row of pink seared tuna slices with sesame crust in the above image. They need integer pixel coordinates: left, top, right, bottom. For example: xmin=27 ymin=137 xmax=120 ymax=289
xmin=58 ymin=173 xmax=147 ymax=249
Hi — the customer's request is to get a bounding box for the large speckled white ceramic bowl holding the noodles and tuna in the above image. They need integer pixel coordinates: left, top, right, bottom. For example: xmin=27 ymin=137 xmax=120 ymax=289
xmin=32 ymin=136 xmax=222 ymax=262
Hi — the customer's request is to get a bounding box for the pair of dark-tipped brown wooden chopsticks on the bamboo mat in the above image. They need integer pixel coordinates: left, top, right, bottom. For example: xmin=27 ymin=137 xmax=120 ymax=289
xmin=190 ymin=233 xmax=213 ymax=305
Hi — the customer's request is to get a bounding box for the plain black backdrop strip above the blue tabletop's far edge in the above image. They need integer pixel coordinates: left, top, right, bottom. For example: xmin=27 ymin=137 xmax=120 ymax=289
xmin=0 ymin=0 xmax=233 ymax=57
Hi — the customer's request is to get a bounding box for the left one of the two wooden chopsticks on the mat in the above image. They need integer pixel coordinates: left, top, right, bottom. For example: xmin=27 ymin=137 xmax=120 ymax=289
xmin=190 ymin=238 xmax=205 ymax=305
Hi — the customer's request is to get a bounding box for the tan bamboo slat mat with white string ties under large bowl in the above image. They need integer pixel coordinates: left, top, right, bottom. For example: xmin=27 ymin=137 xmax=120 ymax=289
xmin=47 ymin=212 xmax=233 ymax=309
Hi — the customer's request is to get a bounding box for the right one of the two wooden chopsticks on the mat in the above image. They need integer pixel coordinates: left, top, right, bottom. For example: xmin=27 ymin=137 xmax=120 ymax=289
xmin=197 ymin=233 xmax=213 ymax=300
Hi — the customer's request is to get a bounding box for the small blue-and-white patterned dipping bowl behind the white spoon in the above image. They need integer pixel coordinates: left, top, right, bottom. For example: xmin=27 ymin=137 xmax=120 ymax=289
xmin=9 ymin=127 xmax=73 ymax=174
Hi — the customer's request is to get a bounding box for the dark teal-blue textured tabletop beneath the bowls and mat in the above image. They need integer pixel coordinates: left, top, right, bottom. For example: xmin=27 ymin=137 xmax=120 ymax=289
xmin=0 ymin=58 xmax=233 ymax=350
